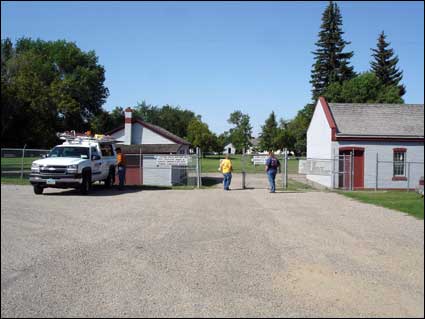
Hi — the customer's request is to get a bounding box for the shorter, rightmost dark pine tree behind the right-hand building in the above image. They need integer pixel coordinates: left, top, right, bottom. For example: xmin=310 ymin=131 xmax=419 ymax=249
xmin=370 ymin=31 xmax=406 ymax=97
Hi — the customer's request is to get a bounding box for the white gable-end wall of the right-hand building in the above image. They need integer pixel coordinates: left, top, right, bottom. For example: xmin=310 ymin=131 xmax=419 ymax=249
xmin=307 ymin=100 xmax=332 ymax=187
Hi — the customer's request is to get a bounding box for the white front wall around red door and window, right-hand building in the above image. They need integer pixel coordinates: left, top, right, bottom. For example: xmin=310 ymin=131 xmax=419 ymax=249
xmin=334 ymin=141 xmax=424 ymax=188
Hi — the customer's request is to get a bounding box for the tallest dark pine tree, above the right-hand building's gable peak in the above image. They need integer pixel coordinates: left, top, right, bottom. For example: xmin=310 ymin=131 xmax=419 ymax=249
xmin=310 ymin=1 xmax=356 ymax=100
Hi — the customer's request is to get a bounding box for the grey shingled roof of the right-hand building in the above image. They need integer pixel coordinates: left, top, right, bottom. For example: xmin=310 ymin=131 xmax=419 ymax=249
xmin=328 ymin=103 xmax=424 ymax=138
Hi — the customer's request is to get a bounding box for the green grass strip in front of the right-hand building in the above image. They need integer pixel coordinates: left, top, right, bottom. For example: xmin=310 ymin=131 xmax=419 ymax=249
xmin=340 ymin=191 xmax=424 ymax=219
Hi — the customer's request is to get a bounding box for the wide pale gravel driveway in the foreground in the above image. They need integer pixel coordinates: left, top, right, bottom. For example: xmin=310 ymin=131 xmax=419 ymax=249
xmin=1 ymin=185 xmax=424 ymax=317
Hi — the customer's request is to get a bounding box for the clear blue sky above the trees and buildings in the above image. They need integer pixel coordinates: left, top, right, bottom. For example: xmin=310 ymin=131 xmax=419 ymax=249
xmin=1 ymin=1 xmax=424 ymax=136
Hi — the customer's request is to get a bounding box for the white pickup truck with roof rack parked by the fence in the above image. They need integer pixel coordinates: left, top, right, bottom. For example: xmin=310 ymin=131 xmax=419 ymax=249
xmin=29 ymin=137 xmax=116 ymax=195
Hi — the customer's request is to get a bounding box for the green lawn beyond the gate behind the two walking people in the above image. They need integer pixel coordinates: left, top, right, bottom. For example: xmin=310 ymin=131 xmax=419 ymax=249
xmin=201 ymin=155 xmax=298 ymax=174
